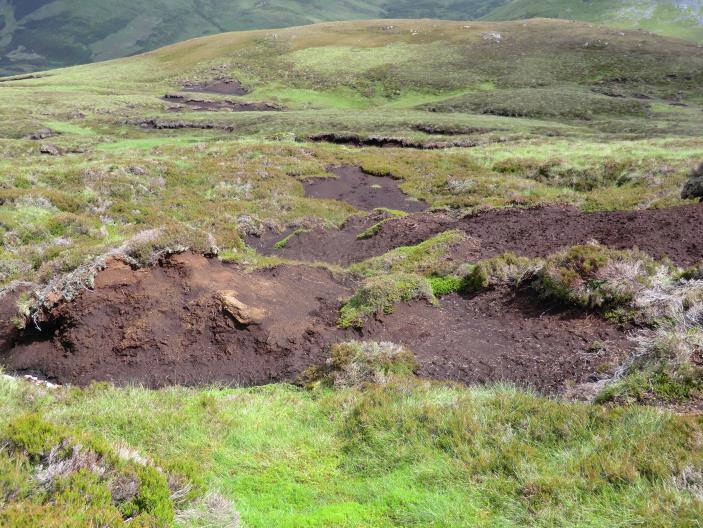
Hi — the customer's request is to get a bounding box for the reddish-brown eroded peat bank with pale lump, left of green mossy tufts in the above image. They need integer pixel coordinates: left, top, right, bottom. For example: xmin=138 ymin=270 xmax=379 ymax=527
xmin=0 ymin=254 xmax=349 ymax=387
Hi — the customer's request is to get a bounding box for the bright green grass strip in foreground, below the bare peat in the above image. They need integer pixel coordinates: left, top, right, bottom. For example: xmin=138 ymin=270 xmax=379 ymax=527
xmin=0 ymin=368 xmax=703 ymax=528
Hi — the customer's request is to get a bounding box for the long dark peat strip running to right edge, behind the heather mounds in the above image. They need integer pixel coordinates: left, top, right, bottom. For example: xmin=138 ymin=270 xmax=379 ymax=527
xmin=248 ymin=204 xmax=703 ymax=266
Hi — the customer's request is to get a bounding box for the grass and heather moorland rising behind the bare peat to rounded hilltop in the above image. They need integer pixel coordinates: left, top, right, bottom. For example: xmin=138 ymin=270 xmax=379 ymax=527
xmin=0 ymin=20 xmax=703 ymax=288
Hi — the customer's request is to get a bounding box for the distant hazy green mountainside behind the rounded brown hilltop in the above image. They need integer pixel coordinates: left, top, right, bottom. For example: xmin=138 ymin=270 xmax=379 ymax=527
xmin=0 ymin=0 xmax=703 ymax=75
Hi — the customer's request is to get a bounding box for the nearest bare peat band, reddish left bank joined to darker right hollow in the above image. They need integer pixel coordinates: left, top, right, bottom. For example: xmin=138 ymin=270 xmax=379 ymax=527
xmin=0 ymin=253 xmax=626 ymax=393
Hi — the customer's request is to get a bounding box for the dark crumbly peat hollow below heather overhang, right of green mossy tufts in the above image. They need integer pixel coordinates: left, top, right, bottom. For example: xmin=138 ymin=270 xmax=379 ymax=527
xmin=363 ymin=291 xmax=629 ymax=393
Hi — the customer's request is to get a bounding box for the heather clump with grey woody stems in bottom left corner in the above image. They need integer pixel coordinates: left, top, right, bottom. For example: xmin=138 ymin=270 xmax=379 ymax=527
xmin=0 ymin=412 xmax=188 ymax=528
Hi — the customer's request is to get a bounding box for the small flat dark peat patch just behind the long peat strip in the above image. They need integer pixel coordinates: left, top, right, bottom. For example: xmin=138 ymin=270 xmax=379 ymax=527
xmin=303 ymin=165 xmax=427 ymax=212
